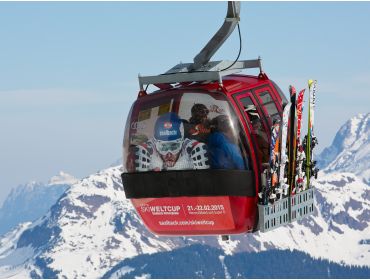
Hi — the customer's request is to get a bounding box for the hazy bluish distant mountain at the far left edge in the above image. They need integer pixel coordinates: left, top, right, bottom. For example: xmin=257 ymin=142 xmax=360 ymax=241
xmin=0 ymin=171 xmax=77 ymax=235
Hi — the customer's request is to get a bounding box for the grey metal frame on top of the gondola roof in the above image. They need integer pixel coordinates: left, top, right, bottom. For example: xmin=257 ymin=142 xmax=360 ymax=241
xmin=139 ymin=57 xmax=263 ymax=90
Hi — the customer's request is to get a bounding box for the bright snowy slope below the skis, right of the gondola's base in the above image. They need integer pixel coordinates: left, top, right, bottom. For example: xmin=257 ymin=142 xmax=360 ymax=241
xmin=251 ymin=173 xmax=370 ymax=266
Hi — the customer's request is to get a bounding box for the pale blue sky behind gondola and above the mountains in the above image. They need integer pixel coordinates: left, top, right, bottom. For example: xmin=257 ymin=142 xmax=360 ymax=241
xmin=0 ymin=2 xmax=370 ymax=204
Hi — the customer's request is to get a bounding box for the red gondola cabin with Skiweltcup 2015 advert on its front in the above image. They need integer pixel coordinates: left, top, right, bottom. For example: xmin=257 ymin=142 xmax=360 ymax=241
xmin=122 ymin=60 xmax=287 ymax=235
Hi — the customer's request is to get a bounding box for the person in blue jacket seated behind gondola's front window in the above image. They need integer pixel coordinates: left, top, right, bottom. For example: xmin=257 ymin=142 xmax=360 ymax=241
xmin=207 ymin=115 xmax=246 ymax=169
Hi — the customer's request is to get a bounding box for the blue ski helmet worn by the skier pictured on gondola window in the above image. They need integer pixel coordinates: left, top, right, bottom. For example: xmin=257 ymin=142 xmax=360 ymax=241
xmin=154 ymin=113 xmax=184 ymax=141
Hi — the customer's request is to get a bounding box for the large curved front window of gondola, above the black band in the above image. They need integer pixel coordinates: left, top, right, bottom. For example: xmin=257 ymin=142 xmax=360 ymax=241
xmin=124 ymin=93 xmax=248 ymax=172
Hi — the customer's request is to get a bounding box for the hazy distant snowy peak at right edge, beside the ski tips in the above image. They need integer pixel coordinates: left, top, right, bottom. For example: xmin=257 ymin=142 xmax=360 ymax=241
xmin=318 ymin=113 xmax=370 ymax=184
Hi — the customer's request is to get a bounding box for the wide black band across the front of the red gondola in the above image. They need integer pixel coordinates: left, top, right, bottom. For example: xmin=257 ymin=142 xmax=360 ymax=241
xmin=121 ymin=169 xmax=256 ymax=198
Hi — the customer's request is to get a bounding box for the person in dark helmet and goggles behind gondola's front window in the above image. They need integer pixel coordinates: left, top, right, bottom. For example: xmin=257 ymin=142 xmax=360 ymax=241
xmin=184 ymin=103 xmax=211 ymax=143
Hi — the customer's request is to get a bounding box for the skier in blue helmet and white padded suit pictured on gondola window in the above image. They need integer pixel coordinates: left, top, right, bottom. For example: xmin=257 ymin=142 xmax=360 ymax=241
xmin=136 ymin=112 xmax=209 ymax=171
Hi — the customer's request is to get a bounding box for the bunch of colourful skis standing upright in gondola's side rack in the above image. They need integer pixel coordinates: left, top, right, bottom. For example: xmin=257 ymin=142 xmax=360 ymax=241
xmin=260 ymin=80 xmax=318 ymax=205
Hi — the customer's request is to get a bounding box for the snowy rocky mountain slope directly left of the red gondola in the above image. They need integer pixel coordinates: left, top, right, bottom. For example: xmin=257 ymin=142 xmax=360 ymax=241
xmin=0 ymin=167 xmax=197 ymax=278
